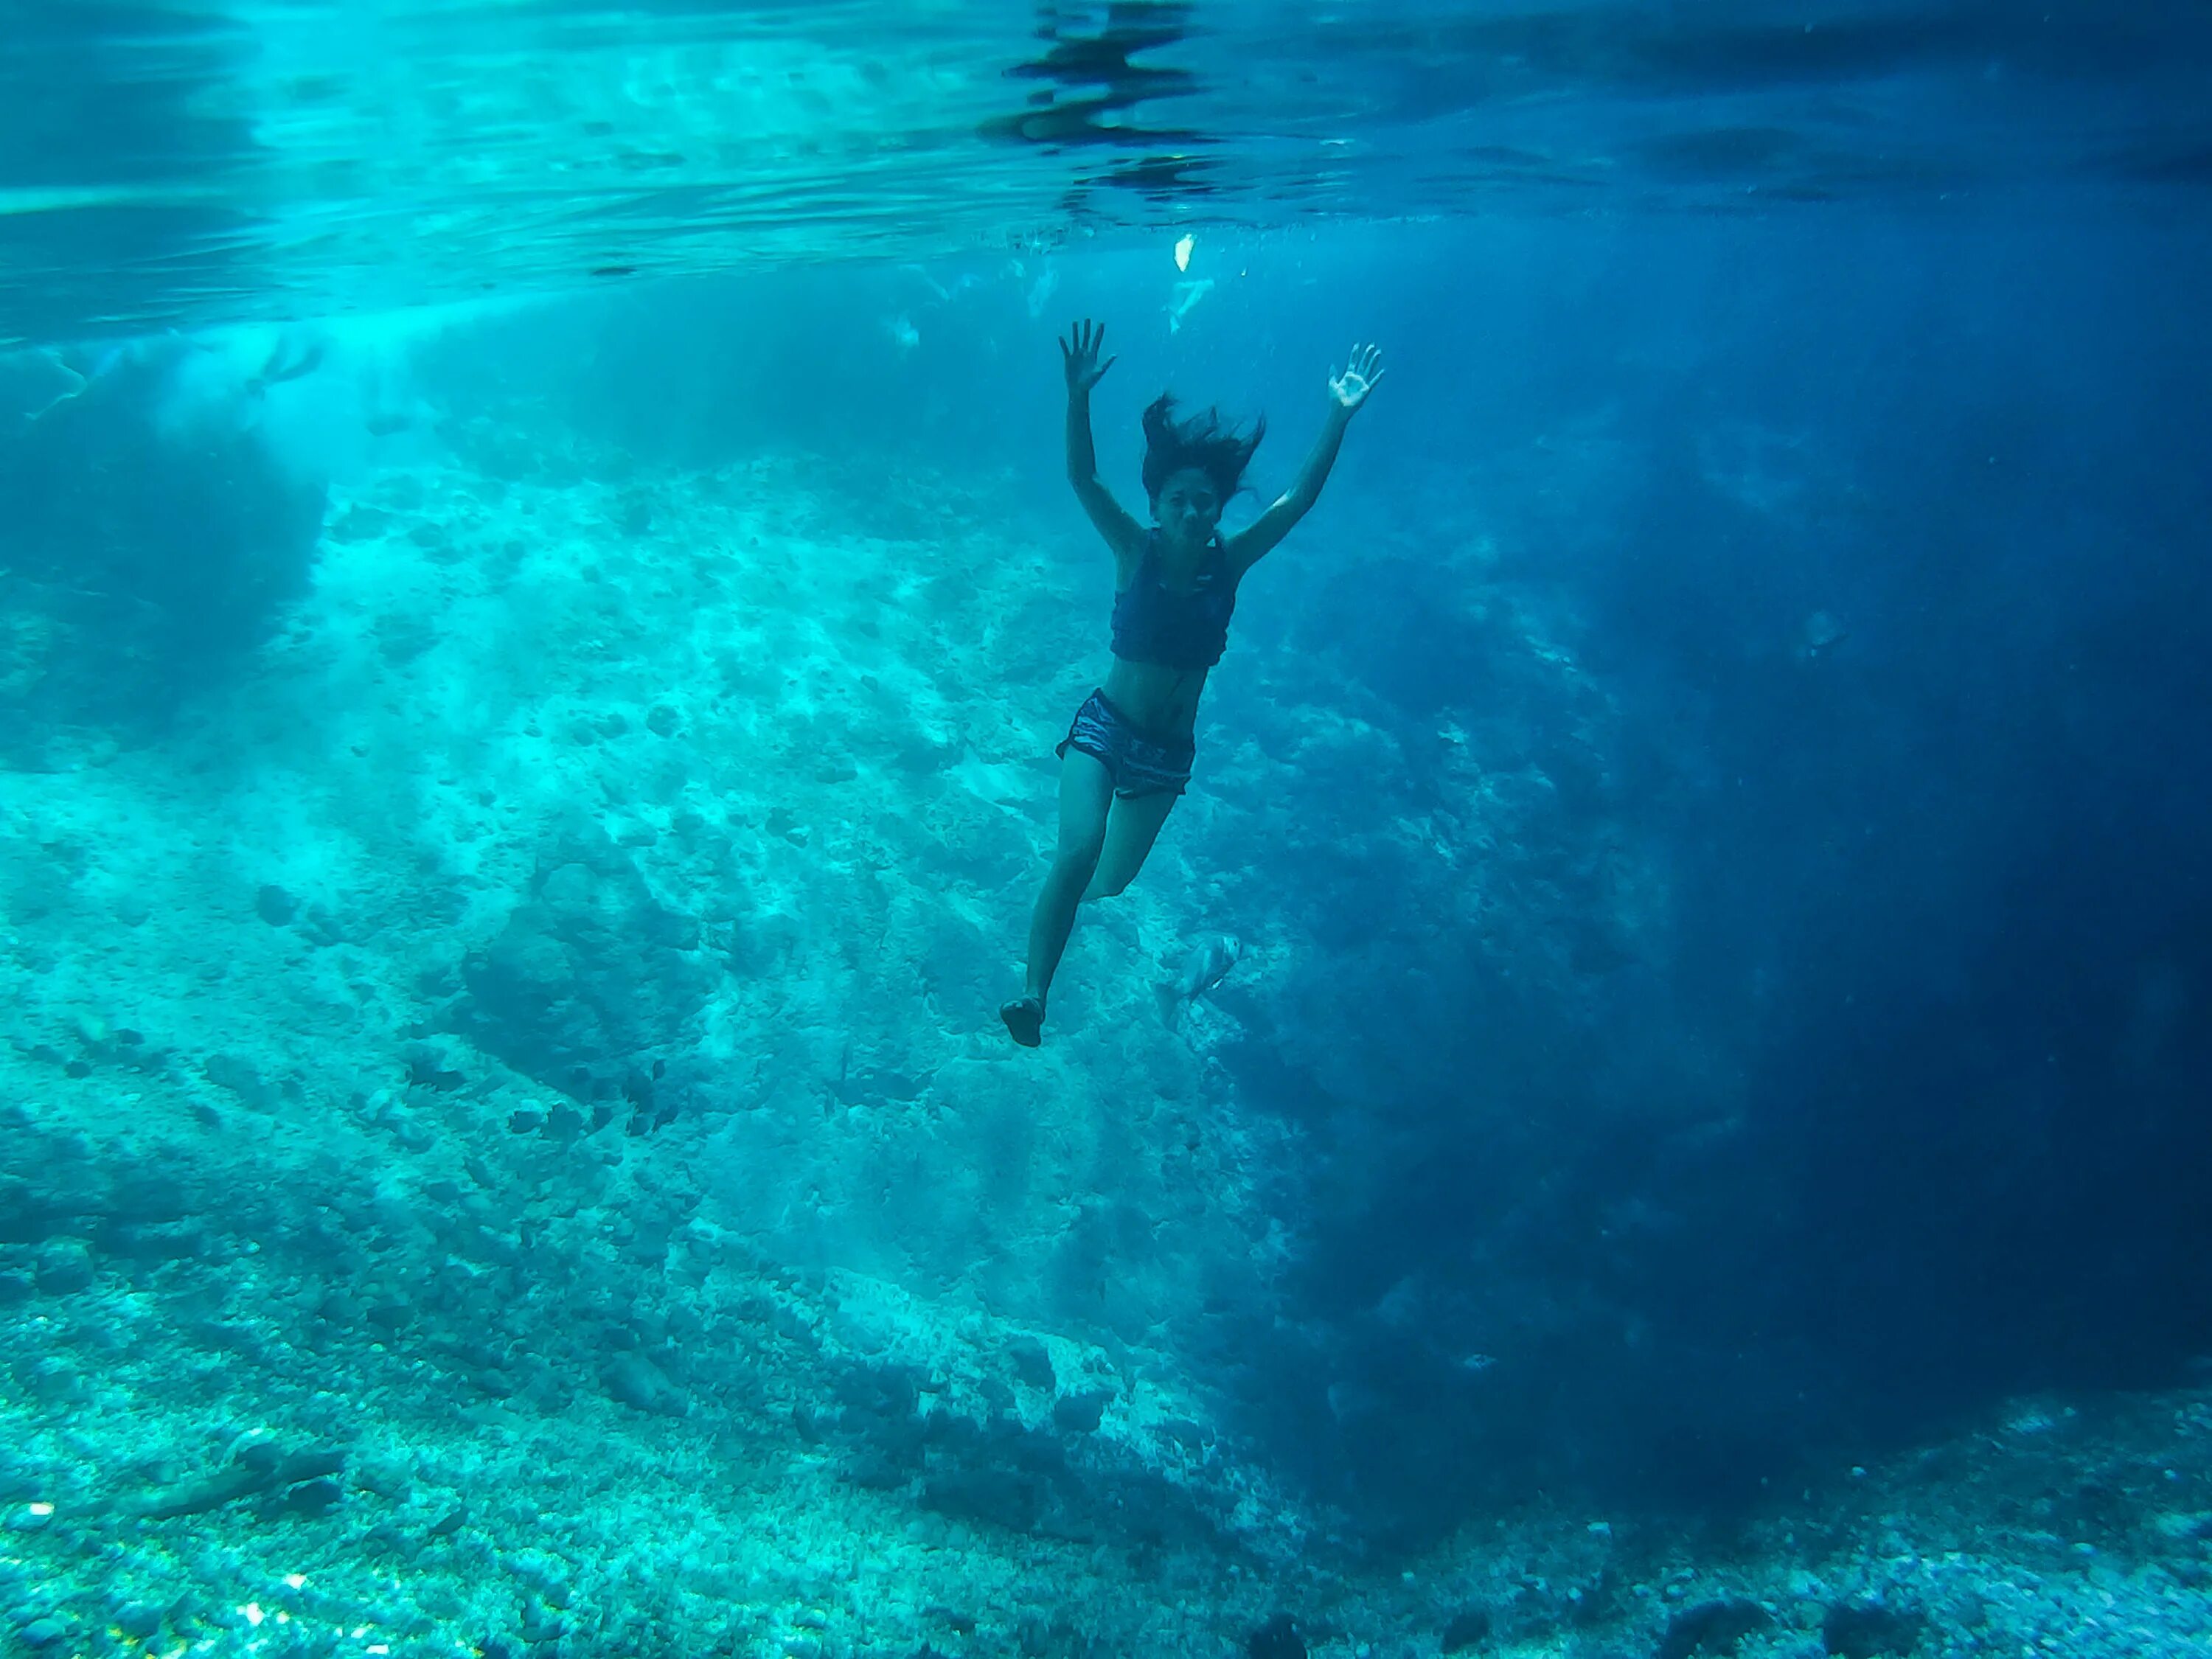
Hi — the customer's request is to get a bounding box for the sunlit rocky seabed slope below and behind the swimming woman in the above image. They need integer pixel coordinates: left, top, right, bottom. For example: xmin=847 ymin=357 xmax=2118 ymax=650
xmin=0 ymin=396 xmax=2212 ymax=1659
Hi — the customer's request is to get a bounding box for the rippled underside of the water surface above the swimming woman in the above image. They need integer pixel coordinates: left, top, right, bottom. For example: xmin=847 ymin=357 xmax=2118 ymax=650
xmin=13 ymin=0 xmax=2212 ymax=343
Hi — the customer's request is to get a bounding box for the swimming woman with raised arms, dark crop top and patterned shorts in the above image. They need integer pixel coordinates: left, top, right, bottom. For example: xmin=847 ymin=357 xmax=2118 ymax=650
xmin=1000 ymin=321 xmax=1382 ymax=1048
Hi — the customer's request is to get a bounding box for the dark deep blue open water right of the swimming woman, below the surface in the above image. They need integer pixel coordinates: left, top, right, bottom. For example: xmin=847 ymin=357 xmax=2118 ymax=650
xmin=418 ymin=208 xmax=2212 ymax=1509
